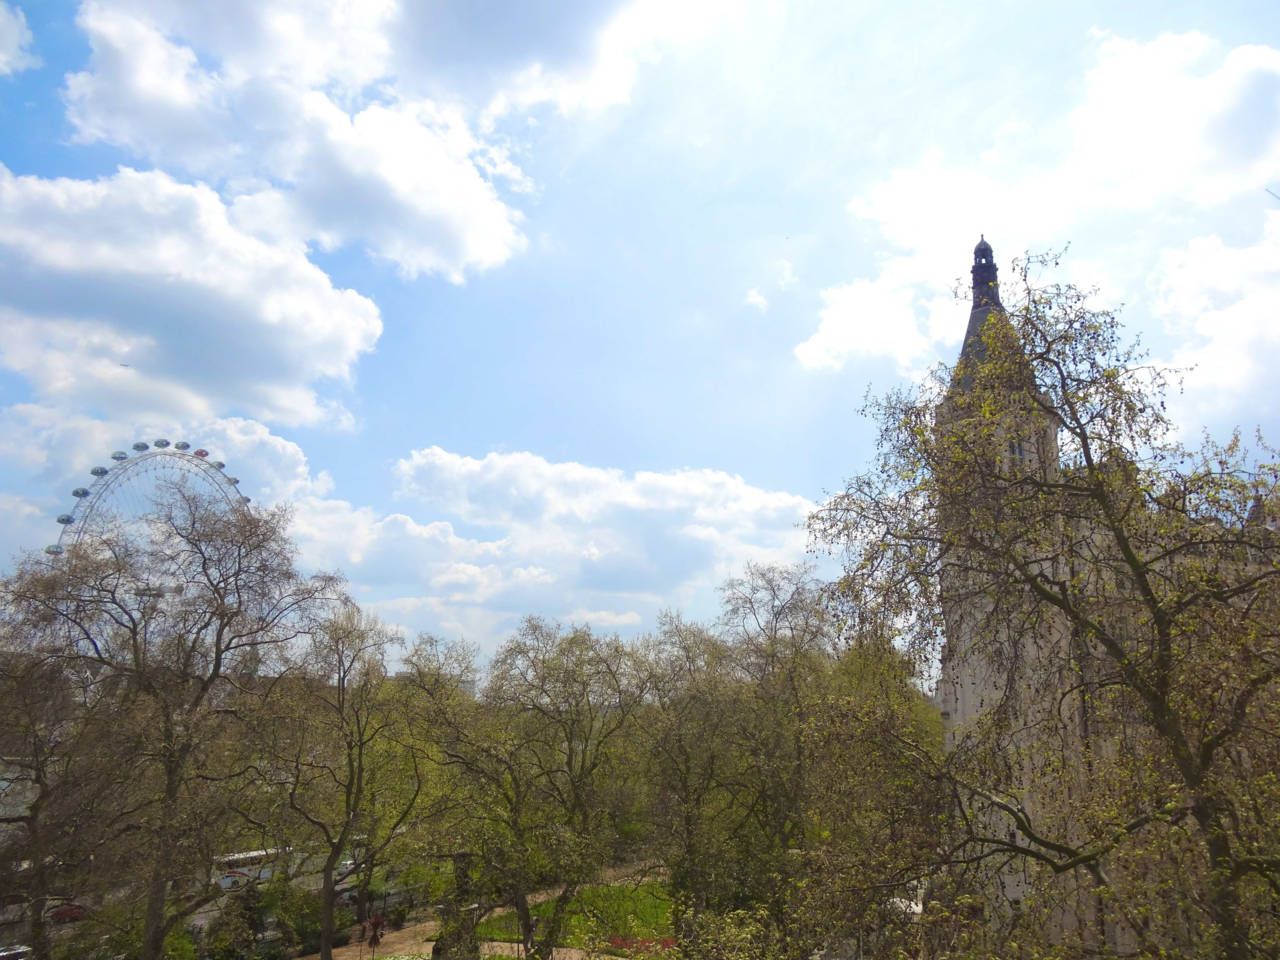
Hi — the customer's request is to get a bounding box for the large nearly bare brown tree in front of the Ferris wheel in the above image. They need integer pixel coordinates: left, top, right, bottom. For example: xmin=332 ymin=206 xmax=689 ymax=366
xmin=4 ymin=485 xmax=334 ymax=960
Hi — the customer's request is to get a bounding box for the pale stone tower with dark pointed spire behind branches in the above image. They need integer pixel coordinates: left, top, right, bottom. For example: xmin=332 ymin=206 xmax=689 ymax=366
xmin=934 ymin=238 xmax=1089 ymax=931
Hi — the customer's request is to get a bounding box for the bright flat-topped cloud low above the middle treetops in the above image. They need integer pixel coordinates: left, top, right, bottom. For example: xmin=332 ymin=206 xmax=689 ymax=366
xmin=384 ymin=447 xmax=813 ymax=626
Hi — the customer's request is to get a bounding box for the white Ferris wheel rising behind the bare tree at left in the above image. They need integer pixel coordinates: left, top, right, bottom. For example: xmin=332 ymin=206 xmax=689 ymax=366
xmin=45 ymin=439 xmax=250 ymax=556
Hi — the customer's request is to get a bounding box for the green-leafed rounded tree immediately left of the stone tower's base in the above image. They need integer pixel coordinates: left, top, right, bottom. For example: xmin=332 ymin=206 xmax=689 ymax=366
xmin=787 ymin=636 xmax=947 ymax=956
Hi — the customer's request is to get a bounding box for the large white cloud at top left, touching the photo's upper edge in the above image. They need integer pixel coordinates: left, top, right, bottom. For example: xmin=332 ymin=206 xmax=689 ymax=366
xmin=65 ymin=0 xmax=530 ymax=282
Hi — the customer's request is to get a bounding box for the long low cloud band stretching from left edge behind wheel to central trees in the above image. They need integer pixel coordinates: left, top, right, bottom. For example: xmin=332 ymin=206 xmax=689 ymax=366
xmin=0 ymin=404 xmax=814 ymax=649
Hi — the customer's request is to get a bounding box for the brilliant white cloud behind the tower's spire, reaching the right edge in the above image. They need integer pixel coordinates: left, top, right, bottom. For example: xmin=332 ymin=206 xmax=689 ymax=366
xmin=795 ymin=33 xmax=1280 ymax=370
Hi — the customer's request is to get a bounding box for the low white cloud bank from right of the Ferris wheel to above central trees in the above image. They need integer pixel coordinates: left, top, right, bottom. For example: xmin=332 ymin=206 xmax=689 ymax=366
xmin=267 ymin=447 xmax=813 ymax=648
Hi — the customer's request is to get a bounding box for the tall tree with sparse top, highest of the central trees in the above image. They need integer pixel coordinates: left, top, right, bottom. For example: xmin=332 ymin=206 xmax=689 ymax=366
xmin=640 ymin=566 xmax=833 ymax=925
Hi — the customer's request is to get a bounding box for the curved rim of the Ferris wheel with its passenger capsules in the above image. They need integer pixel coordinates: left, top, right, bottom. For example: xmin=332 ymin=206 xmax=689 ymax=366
xmin=45 ymin=439 xmax=250 ymax=556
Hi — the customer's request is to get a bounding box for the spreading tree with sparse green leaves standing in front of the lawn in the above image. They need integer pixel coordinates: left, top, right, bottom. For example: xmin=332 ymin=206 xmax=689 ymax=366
xmin=413 ymin=617 xmax=646 ymax=960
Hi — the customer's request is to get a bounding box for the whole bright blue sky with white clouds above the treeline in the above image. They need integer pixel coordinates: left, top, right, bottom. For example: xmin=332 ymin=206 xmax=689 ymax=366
xmin=0 ymin=0 xmax=1280 ymax=650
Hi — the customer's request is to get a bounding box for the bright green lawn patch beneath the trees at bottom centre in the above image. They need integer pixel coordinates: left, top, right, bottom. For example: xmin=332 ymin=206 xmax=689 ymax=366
xmin=476 ymin=882 xmax=671 ymax=947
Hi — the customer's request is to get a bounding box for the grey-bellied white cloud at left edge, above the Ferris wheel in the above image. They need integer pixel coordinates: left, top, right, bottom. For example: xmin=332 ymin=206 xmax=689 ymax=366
xmin=0 ymin=166 xmax=381 ymax=424
